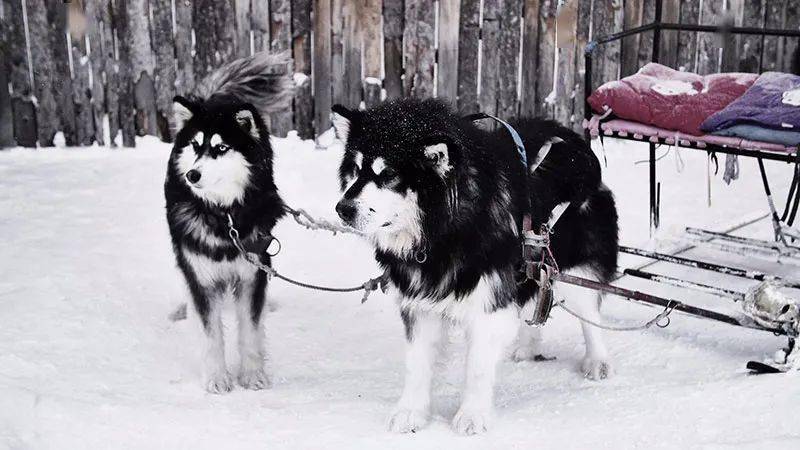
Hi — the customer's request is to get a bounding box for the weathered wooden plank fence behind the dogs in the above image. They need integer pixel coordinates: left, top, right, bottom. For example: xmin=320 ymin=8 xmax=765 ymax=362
xmin=0 ymin=0 xmax=800 ymax=147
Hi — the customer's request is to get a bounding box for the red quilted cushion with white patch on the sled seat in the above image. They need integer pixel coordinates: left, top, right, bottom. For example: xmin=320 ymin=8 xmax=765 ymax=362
xmin=589 ymin=63 xmax=758 ymax=135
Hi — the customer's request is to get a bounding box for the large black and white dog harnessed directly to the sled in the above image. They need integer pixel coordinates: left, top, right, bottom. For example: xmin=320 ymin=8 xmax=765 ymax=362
xmin=333 ymin=99 xmax=618 ymax=434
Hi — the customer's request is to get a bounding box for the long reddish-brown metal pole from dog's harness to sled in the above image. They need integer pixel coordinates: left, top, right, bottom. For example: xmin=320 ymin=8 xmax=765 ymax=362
xmin=555 ymin=273 xmax=787 ymax=335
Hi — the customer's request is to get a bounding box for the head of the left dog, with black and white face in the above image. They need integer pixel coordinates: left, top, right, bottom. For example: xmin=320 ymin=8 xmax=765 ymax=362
xmin=173 ymin=95 xmax=270 ymax=207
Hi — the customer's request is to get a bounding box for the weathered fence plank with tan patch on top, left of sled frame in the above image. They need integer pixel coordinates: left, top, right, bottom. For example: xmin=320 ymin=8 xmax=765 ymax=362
xmin=553 ymin=0 xmax=582 ymax=128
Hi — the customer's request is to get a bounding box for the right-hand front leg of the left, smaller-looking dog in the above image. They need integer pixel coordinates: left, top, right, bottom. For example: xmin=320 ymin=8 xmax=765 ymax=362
xmin=236 ymin=271 xmax=270 ymax=390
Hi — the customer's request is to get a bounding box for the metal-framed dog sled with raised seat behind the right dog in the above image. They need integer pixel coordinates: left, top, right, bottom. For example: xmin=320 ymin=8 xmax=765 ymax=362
xmin=576 ymin=0 xmax=800 ymax=373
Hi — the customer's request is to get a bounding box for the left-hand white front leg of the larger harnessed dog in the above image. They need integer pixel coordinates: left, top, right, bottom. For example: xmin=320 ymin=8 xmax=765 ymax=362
xmin=389 ymin=311 xmax=442 ymax=433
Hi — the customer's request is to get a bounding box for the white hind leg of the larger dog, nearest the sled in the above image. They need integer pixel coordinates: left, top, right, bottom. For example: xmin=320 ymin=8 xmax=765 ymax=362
xmin=553 ymin=268 xmax=614 ymax=380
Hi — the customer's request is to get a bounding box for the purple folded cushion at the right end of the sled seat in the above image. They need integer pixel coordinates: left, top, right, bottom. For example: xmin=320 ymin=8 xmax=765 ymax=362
xmin=701 ymin=72 xmax=800 ymax=132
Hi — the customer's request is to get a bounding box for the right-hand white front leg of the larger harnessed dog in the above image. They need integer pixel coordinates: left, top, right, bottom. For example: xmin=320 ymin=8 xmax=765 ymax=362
xmin=453 ymin=306 xmax=519 ymax=434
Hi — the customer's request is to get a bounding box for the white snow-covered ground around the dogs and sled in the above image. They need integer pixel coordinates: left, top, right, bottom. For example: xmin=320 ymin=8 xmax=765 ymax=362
xmin=0 ymin=138 xmax=800 ymax=450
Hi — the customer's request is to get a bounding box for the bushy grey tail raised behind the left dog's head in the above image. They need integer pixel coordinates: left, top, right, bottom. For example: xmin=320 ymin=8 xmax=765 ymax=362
xmin=198 ymin=52 xmax=294 ymax=115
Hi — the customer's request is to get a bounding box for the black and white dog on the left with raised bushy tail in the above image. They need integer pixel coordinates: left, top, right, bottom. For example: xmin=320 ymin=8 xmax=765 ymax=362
xmin=164 ymin=53 xmax=293 ymax=393
